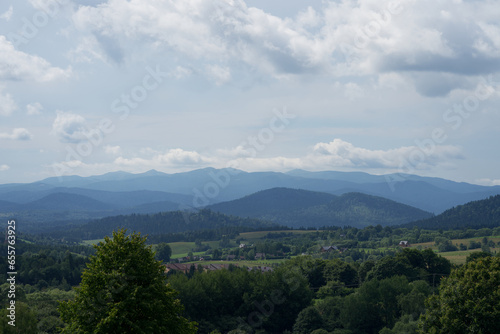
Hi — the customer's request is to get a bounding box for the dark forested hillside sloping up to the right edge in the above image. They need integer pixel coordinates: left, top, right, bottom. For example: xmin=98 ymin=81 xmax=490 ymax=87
xmin=403 ymin=195 xmax=500 ymax=230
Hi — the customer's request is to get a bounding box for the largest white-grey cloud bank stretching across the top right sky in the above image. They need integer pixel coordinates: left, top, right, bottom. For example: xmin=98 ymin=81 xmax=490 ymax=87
xmin=67 ymin=0 xmax=500 ymax=92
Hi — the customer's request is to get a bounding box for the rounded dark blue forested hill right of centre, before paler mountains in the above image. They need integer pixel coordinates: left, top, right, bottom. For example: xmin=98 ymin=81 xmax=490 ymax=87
xmin=208 ymin=188 xmax=432 ymax=227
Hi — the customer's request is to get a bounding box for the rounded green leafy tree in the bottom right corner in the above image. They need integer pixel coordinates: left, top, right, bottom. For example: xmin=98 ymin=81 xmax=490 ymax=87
xmin=420 ymin=257 xmax=500 ymax=334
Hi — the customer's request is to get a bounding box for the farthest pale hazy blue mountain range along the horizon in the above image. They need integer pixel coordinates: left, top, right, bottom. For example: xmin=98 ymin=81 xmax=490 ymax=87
xmin=0 ymin=168 xmax=500 ymax=214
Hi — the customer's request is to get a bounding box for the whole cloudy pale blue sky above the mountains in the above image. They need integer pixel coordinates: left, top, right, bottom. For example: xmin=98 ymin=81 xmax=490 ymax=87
xmin=0 ymin=0 xmax=500 ymax=185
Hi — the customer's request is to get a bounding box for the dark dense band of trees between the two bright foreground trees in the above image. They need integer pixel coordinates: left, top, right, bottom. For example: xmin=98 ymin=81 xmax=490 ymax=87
xmin=168 ymin=249 xmax=451 ymax=334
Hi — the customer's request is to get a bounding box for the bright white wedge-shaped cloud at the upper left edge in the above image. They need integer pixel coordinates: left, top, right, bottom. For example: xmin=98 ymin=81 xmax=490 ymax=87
xmin=0 ymin=35 xmax=72 ymax=82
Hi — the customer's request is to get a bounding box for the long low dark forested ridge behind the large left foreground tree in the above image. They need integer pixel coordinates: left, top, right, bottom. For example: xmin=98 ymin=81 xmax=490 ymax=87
xmin=48 ymin=209 xmax=284 ymax=240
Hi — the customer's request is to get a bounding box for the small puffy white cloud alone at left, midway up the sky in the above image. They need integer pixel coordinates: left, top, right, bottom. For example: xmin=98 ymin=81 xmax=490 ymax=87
xmin=52 ymin=111 xmax=88 ymax=143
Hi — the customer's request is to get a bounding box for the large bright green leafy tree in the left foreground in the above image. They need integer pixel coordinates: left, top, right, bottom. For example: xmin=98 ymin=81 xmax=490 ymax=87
xmin=59 ymin=230 xmax=196 ymax=334
